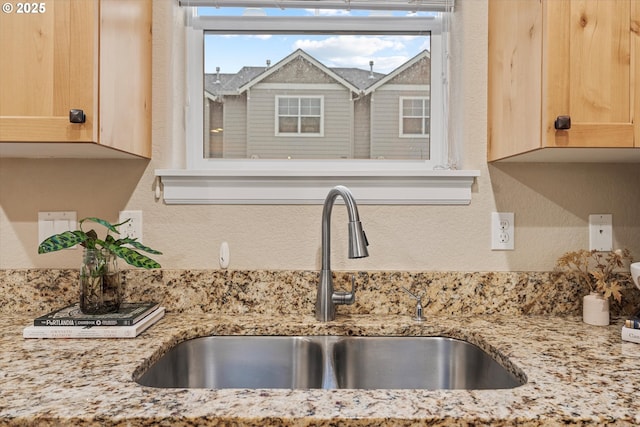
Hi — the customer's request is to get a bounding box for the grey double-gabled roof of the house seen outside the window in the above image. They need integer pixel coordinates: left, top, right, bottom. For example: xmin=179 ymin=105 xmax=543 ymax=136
xmin=204 ymin=49 xmax=430 ymax=95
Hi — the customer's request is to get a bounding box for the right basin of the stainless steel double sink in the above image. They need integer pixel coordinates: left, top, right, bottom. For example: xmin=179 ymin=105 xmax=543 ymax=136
xmin=333 ymin=337 xmax=522 ymax=390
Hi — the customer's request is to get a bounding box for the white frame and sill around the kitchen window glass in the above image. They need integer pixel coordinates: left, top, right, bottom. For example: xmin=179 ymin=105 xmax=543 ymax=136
xmin=155 ymin=10 xmax=480 ymax=205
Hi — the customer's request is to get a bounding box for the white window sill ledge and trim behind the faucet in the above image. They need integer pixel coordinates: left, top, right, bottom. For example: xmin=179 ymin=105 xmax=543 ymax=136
xmin=155 ymin=169 xmax=480 ymax=205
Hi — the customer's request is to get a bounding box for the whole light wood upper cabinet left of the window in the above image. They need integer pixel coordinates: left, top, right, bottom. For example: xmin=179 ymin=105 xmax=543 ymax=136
xmin=0 ymin=0 xmax=151 ymax=158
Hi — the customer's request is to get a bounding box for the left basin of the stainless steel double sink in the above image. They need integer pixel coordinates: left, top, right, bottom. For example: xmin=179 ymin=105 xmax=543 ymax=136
xmin=138 ymin=336 xmax=323 ymax=388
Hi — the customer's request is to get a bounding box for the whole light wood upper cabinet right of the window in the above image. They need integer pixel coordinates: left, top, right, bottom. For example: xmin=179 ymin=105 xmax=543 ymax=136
xmin=487 ymin=0 xmax=640 ymax=162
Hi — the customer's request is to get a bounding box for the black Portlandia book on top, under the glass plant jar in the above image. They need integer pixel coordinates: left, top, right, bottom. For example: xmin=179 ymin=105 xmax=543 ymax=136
xmin=33 ymin=302 xmax=159 ymax=326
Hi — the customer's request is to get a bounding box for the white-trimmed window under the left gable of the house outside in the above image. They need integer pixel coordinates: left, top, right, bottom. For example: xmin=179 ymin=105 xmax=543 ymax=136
xmin=276 ymin=96 xmax=323 ymax=136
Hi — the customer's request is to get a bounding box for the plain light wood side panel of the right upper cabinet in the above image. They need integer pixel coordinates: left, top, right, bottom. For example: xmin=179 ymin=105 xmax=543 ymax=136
xmin=487 ymin=0 xmax=543 ymax=161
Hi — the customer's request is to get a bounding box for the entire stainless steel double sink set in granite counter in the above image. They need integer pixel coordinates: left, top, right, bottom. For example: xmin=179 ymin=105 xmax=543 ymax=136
xmin=137 ymin=336 xmax=525 ymax=389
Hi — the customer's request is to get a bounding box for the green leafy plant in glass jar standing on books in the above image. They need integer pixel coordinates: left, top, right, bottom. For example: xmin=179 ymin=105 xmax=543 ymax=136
xmin=38 ymin=217 xmax=162 ymax=314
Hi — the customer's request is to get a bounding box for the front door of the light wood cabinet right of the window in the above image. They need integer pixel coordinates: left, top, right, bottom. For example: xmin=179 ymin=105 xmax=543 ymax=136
xmin=543 ymin=0 xmax=640 ymax=147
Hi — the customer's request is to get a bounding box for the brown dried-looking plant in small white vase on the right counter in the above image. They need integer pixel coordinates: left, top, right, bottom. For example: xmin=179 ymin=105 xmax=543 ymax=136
xmin=556 ymin=249 xmax=632 ymax=326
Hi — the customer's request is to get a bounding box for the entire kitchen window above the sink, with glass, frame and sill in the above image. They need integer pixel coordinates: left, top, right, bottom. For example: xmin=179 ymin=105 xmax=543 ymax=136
xmin=156 ymin=0 xmax=477 ymax=203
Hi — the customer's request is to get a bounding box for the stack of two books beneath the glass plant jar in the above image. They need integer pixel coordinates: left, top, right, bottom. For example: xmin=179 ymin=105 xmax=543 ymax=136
xmin=22 ymin=302 xmax=164 ymax=338
